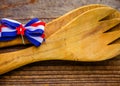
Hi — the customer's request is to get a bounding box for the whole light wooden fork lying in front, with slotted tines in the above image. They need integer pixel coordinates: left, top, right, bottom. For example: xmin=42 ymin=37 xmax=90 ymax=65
xmin=0 ymin=7 xmax=120 ymax=74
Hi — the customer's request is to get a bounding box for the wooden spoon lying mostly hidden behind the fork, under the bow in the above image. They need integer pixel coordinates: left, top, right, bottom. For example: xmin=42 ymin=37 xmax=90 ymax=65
xmin=0 ymin=4 xmax=105 ymax=48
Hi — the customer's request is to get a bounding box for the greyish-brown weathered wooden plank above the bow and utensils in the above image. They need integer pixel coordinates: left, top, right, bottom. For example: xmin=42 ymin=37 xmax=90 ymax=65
xmin=0 ymin=0 xmax=120 ymax=20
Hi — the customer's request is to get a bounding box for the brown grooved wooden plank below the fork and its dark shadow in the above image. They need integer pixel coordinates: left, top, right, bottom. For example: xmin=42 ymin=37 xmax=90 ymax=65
xmin=0 ymin=61 xmax=120 ymax=84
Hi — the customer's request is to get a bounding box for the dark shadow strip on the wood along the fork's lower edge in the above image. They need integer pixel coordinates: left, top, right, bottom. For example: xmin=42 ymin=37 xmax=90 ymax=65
xmin=0 ymin=55 xmax=120 ymax=76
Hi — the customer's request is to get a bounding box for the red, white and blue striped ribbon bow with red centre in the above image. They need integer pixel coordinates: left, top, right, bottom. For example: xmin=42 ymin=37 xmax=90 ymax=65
xmin=0 ymin=18 xmax=45 ymax=46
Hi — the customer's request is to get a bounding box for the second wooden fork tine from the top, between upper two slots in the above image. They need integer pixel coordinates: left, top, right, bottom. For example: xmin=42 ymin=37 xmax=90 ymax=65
xmin=98 ymin=18 xmax=120 ymax=32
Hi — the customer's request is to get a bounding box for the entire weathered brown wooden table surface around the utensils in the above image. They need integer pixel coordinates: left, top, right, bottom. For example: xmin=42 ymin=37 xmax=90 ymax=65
xmin=0 ymin=0 xmax=120 ymax=86
